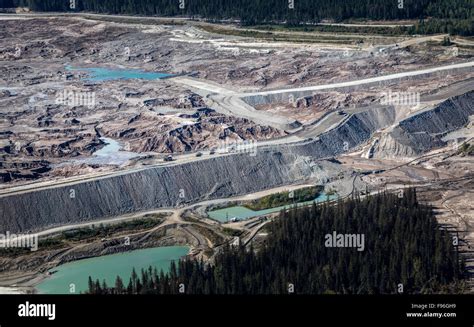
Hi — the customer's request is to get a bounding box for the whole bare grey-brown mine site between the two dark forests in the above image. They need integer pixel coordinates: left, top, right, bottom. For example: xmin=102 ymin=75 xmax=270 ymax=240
xmin=0 ymin=13 xmax=474 ymax=292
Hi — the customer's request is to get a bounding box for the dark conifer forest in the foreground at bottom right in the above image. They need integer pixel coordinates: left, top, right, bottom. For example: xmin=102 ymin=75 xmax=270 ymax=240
xmin=89 ymin=189 xmax=464 ymax=294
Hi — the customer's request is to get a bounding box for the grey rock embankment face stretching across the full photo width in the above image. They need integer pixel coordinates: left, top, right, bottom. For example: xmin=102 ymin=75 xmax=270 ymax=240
xmin=0 ymin=92 xmax=474 ymax=232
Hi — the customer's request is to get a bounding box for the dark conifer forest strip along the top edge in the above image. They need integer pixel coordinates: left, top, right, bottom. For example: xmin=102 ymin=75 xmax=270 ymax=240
xmin=0 ymin=0 xmax=474 ymax=35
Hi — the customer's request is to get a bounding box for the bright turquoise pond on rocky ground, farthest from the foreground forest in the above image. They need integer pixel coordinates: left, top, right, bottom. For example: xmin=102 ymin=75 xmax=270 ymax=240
xmin=66 ymin=66 xmax=173 ymax=82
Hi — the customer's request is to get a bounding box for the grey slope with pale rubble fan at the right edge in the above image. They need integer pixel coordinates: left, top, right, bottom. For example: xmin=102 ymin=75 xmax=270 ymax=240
xmin=375 ymin=91 xmax=474 ymax=158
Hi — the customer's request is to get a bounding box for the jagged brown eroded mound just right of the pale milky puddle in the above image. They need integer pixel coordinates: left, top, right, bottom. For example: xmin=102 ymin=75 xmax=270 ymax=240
xmin=101 ymin=108 xmax=285 ymax=153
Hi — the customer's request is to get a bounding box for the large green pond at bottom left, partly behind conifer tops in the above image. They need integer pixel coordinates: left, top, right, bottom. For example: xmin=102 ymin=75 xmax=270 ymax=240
xmin=36 ymin=246 xmax=189 ymax=294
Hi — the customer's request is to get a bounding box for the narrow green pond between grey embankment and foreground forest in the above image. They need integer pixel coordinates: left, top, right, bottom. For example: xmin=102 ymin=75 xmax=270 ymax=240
xmin=207 ymin=193 xmax=338 ymax=223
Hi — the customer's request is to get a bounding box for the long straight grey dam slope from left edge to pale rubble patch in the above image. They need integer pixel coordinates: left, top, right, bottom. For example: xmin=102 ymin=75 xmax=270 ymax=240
xmin=0 ymin=151 xmax=335 ymax=233
